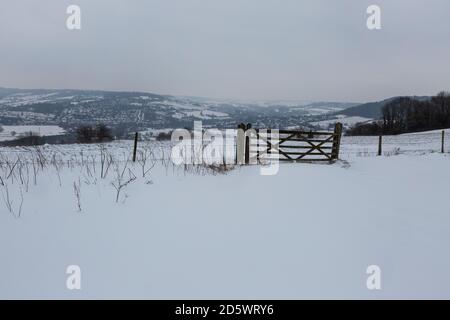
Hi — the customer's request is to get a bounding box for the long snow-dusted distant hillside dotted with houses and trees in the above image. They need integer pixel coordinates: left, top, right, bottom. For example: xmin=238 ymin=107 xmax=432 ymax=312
xmin=0 ymin=88 xmax=356 ymax=132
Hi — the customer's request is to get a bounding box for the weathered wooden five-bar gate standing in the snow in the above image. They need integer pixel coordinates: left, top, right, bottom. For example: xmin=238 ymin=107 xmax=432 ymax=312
xmin=241 ymin=123 xmax=342 ymax=163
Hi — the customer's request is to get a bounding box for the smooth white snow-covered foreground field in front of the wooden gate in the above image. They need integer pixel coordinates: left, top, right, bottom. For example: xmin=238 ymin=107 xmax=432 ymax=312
xmin=0 ymin=131 xmax=450 ymax=299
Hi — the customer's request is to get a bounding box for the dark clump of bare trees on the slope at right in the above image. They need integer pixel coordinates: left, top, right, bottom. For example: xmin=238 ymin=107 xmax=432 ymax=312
xmin=347 ymin=92 xmax=450 ymax=135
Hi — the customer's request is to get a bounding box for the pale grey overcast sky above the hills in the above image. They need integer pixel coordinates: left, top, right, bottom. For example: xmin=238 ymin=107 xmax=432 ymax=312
xmin=0 ymin=0 xmax=450 ymax=102
